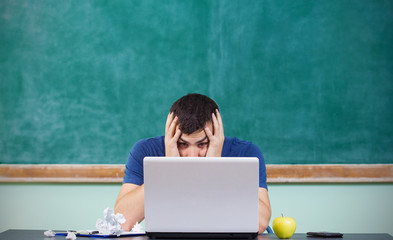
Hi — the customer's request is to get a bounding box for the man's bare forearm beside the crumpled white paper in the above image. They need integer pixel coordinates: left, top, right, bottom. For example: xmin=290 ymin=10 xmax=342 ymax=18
xmin=115 ymin=185 xmax=145 ymax=231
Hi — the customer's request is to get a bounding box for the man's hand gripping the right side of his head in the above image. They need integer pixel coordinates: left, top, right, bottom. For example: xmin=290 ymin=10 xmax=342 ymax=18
xmin=205 ymin=109 xmax=225 ymax=157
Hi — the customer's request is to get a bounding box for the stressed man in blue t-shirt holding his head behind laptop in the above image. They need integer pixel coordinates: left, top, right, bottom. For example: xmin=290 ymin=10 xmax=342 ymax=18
xmin=115 ymin=94 xmax=271 ymax=233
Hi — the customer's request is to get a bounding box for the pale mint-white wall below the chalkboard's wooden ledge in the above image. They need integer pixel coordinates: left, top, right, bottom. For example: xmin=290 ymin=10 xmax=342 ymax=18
xmin=0 ymin=183 xmax=393 ymax=235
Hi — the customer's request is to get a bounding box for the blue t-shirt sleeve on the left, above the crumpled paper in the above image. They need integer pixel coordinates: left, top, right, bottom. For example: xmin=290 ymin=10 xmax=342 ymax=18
xmin=123 ymin=140 xmax=146 ymax=185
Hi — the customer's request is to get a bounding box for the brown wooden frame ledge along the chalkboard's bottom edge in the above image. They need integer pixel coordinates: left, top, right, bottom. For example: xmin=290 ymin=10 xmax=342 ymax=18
xmin=0 ymin=164 xmax=393 ymax=183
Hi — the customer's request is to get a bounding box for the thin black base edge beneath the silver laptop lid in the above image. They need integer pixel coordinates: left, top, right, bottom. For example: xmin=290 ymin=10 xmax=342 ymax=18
xmin=146 ymin=232 xmax=258 ymax=239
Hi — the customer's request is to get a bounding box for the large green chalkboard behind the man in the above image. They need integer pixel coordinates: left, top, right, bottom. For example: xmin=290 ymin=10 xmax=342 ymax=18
xmin=0 ymin=0 xmax=393 ymax=164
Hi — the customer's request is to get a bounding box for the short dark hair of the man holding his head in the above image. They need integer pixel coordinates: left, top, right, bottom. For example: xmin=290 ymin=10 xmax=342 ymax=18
xmin=169 ymin=93 xmax=218 ymax=134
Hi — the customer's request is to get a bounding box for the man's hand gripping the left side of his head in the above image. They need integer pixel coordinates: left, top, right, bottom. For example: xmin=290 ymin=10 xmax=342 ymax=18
xmin=165 ymin=112 xmax=181 ymax=157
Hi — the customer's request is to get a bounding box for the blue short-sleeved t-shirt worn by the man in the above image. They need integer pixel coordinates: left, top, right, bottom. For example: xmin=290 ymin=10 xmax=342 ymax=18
xmin=123 ymin=136 xmax=267 ymax=189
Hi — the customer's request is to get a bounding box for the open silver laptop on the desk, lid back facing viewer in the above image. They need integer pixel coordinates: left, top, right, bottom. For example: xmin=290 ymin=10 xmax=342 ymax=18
xmin=144 ymin=157 xmax=259 ymax=238
